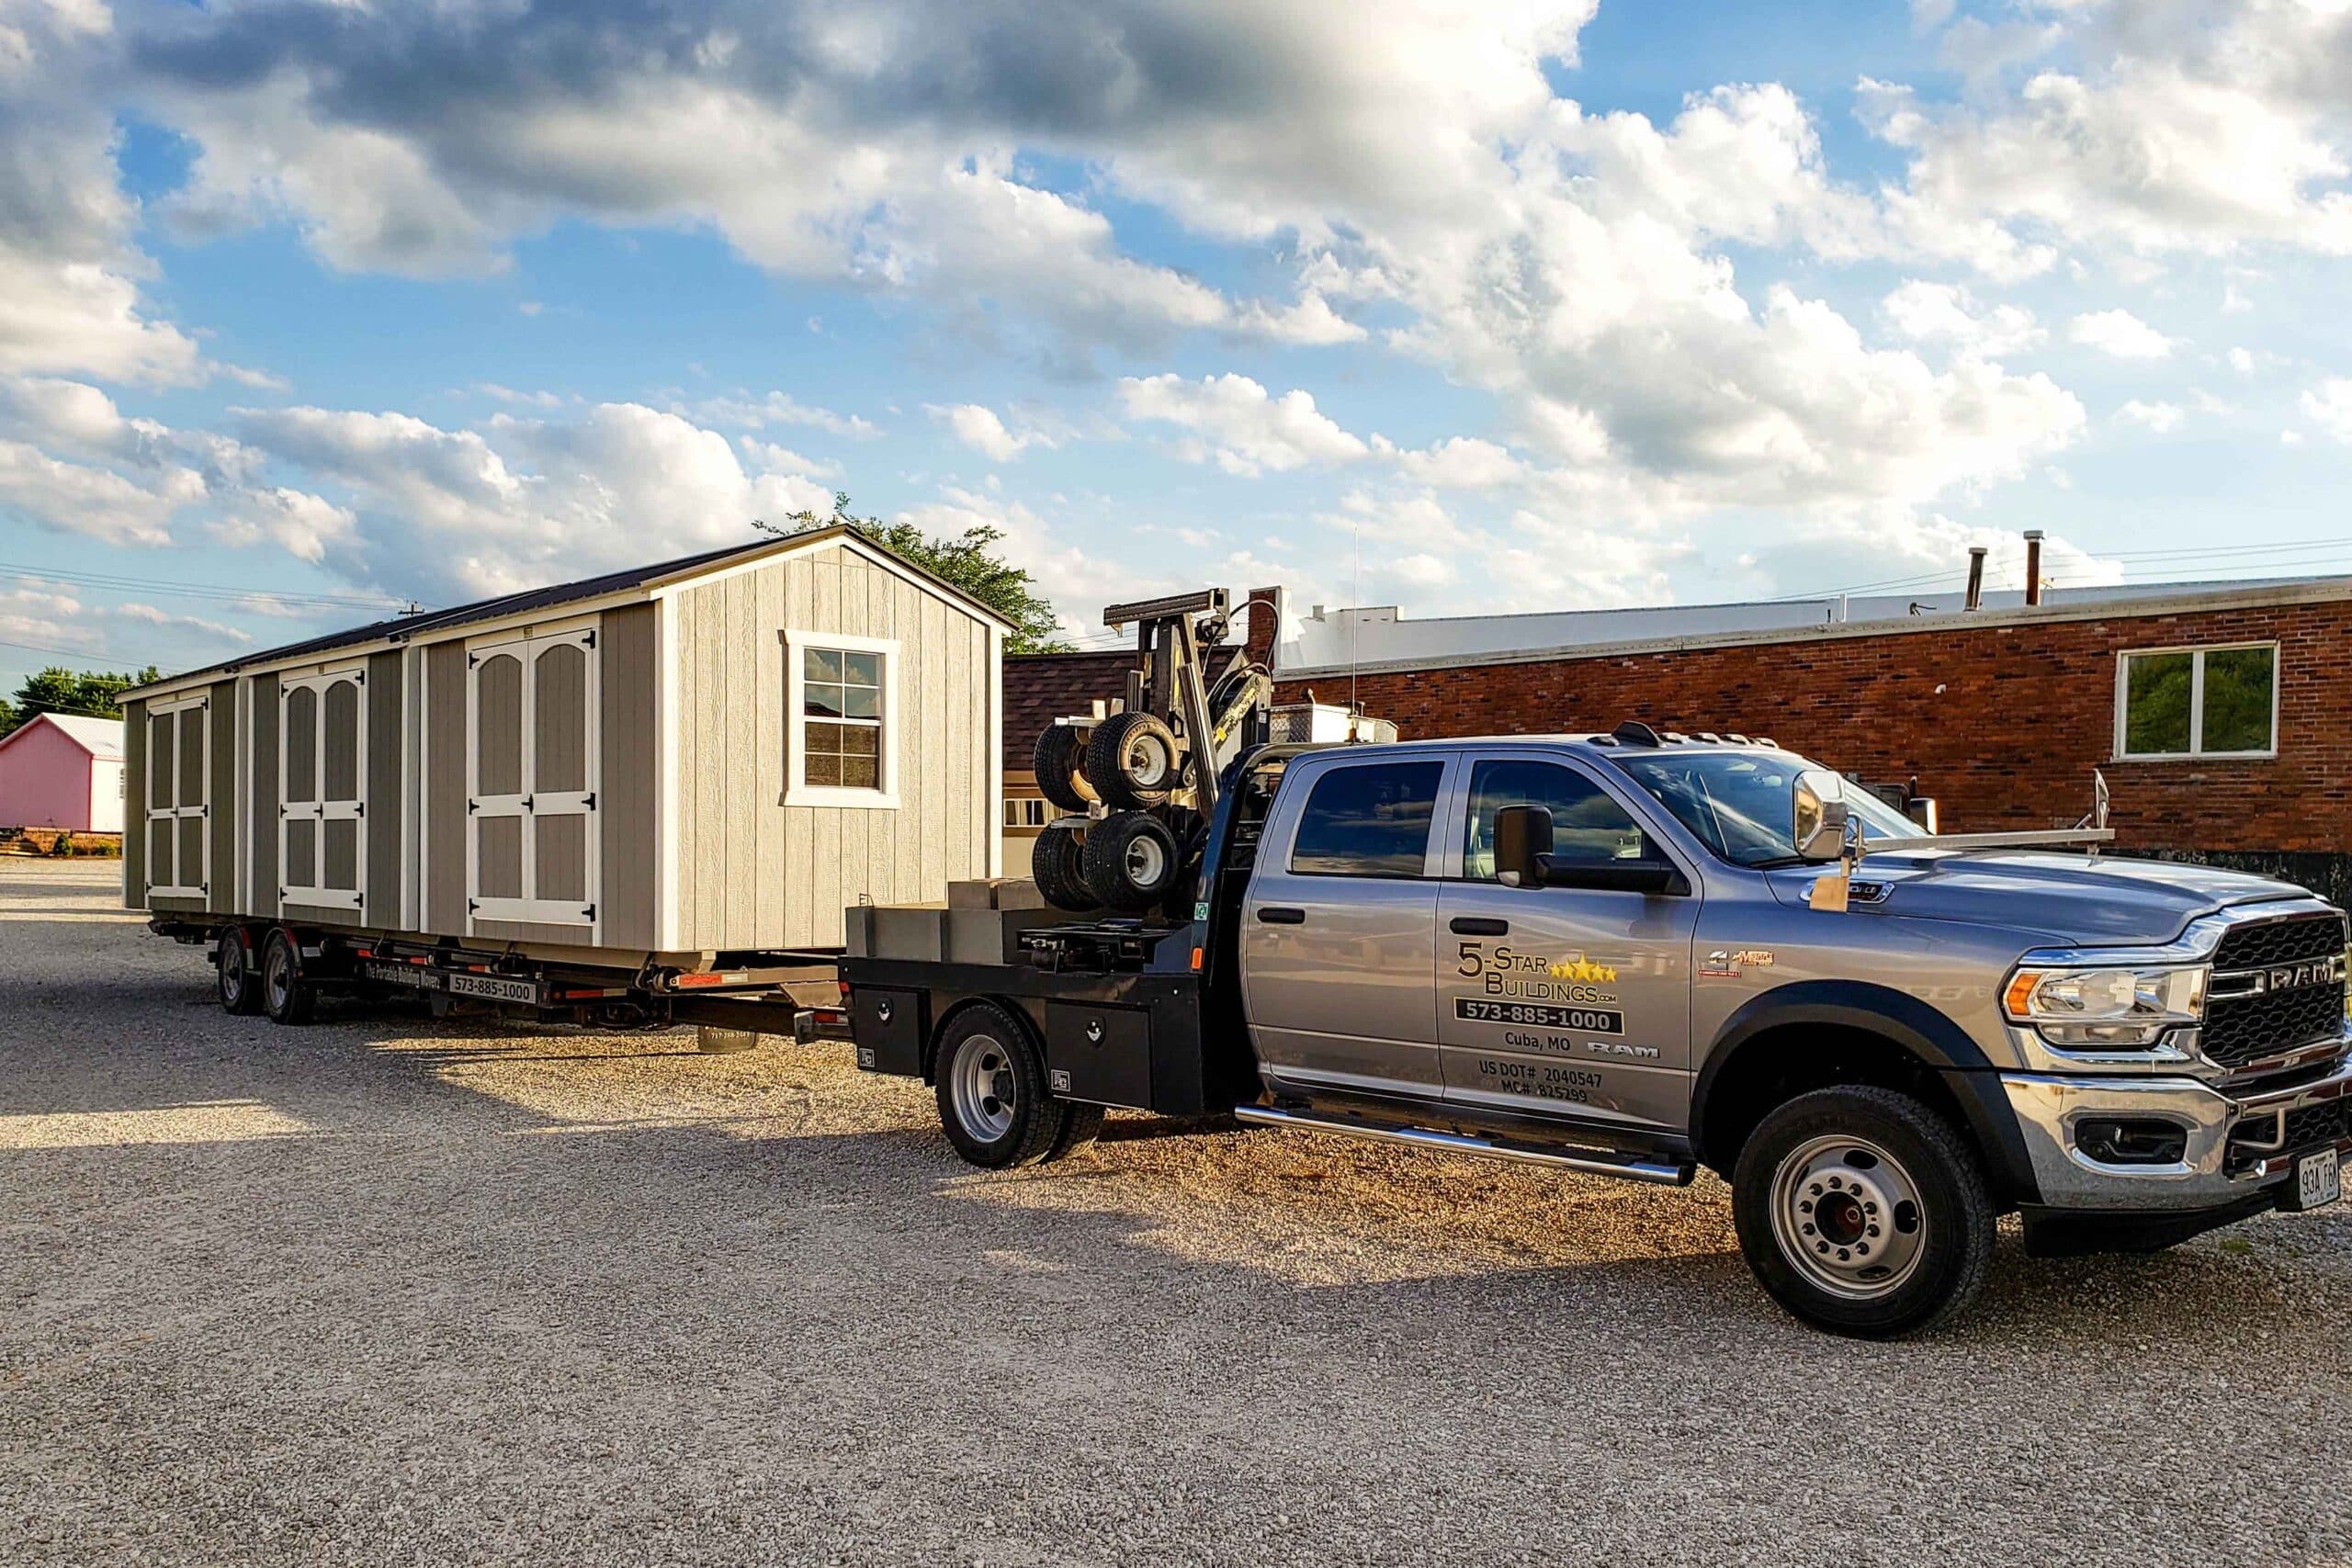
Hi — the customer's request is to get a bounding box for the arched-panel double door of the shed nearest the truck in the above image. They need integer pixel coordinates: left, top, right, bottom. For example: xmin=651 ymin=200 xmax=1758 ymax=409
xmin=466 ymin=626 xmax=602 ymax=931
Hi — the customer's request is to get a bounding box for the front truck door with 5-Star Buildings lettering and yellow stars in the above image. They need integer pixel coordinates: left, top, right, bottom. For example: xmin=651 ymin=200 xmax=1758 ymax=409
xmin=1437 ymin=752 xmax=1698 ymax=1131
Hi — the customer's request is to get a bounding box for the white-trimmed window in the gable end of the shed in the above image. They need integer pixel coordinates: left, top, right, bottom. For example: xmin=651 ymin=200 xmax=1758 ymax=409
xmin=783 ymin=632 xmax=899 ymax=808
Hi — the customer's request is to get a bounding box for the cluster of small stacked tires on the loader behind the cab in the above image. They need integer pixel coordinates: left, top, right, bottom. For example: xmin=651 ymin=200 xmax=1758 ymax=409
xmin=1030 ymin=712 xmax=1200 ymax=915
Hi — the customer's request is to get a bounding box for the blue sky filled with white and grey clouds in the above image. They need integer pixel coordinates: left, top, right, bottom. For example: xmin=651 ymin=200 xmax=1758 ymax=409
xmin=0 ymin=0 xmax=2352 ymax=691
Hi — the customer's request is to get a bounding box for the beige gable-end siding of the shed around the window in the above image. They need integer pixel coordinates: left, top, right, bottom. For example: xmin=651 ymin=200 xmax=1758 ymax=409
xmin=671 ymin=546 xmax=995 ymax=950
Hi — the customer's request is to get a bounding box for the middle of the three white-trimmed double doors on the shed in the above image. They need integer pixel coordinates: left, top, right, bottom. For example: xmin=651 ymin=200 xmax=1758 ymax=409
xmin=277 ymin=668 xmax=367 ymax=919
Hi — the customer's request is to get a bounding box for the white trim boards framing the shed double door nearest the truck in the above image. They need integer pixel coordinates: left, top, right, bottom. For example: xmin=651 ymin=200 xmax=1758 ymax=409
xmin=466 ymin=618 xmax=605 ymax=941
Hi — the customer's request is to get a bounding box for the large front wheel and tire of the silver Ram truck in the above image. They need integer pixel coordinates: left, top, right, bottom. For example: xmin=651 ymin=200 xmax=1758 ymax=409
xmin=1731 ymin=1086 xmax=1999 ymax=1340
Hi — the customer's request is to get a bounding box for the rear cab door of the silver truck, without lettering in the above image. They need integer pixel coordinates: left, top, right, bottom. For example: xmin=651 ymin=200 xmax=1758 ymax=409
xmin=1242 ymin=752 xmax=1452 ymax=1100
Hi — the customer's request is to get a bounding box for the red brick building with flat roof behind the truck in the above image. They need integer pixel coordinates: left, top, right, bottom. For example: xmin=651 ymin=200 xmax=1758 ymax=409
xmin=1251 ymin=579 xmax=2352 ymax=903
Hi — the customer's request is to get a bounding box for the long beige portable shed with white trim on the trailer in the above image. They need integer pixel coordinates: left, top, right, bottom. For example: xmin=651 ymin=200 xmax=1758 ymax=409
xmin=122 ymin=526 xmax=1009 ymax=971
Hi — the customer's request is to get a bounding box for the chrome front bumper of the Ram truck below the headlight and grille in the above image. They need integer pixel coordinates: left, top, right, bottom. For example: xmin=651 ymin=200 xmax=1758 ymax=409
xmin=2002 ymin=1058 xmax=2352 ymax=1213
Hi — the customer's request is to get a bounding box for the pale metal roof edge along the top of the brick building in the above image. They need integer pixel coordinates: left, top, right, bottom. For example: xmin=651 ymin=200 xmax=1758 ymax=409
xmin=1275 ymin=576 xmax=2352 ymax=682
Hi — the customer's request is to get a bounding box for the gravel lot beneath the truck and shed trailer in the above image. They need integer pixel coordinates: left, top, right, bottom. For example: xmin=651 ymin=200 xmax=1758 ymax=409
xmin=0 ymin=861 xmax=2352 ymax=1568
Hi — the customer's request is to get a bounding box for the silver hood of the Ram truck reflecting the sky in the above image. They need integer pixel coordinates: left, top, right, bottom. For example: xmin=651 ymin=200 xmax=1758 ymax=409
xmin=1771 ymin=851 xmax=2310 ymax=947
